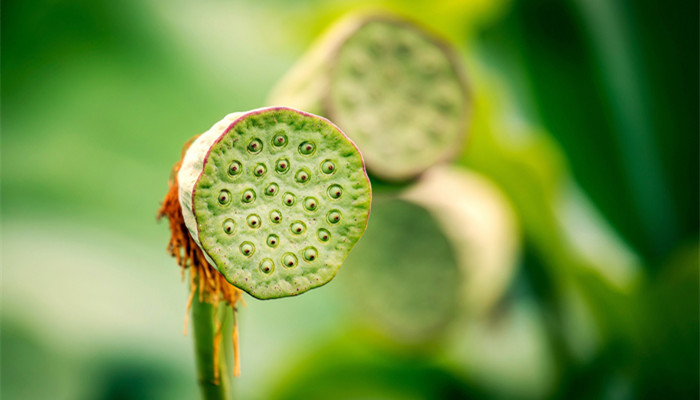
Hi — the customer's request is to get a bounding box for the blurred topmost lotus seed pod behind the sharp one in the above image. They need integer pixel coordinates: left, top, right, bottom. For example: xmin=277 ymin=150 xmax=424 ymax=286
xmin=269 ymin=15 xmax=470 ymax=181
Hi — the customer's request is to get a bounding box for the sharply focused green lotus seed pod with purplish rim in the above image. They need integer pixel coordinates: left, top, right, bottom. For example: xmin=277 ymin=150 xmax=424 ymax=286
xmin=178 ymin=107 xmax=371 ymax=299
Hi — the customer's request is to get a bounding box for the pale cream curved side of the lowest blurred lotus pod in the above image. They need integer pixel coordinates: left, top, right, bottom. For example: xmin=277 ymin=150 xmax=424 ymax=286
xmin=402 ymin=166 xmax=519 ymax=314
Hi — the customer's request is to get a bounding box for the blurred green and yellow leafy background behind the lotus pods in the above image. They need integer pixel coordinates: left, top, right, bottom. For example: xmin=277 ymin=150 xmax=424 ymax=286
xmin=0 ymin=0 xmax=700 ymax=400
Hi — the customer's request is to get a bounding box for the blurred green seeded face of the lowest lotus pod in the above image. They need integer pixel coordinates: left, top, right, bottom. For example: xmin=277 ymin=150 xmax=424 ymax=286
xmin=345 ymin=199 xmax=463 ymax=343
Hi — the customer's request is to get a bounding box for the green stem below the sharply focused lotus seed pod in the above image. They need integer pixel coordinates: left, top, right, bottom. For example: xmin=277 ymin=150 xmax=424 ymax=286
xmin=192 ymin=291 xmax=231 ymax=400
